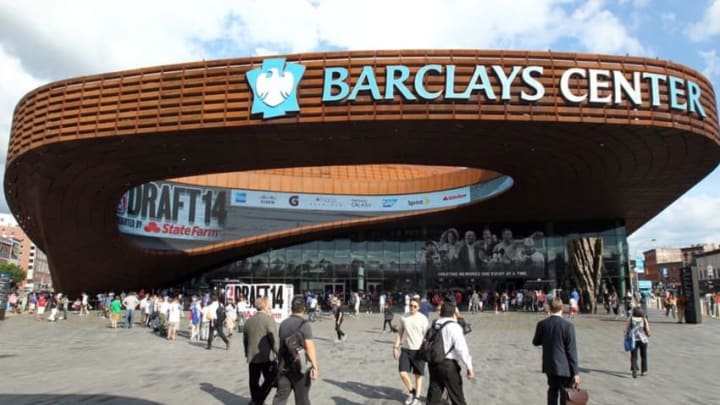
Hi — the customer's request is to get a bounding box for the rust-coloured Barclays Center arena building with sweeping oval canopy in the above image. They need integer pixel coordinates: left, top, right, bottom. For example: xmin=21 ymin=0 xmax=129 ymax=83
xmin=5 ymin=50 xmax=720 ymax=294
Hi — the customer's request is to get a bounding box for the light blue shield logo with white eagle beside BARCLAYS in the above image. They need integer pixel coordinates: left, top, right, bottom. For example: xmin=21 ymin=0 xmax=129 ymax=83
xmin=245 ymin=58 xmax=305 ymax=119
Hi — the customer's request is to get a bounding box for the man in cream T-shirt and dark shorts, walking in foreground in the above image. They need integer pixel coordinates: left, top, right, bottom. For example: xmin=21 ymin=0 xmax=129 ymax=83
xmin=393 ymin=298 xmax=428 ymax=405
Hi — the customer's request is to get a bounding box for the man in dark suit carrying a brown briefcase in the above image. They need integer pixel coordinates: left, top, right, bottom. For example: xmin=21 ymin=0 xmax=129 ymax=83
xmin=533 ymin=298 xmax=580 ymax=405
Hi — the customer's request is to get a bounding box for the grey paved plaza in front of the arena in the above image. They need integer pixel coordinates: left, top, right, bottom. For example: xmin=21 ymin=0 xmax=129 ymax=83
xmin=0 ymin=311 xmax=720 ymax=405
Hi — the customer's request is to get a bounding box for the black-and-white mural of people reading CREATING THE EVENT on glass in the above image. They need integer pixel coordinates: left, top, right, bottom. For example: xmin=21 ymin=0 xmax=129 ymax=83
xmin=423 ymin=227 xmax=546 ymax=279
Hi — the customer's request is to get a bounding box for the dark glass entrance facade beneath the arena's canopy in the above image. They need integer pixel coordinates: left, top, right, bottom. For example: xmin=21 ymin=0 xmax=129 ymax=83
xmin=203 ymin=220 xmax=628 ymax=293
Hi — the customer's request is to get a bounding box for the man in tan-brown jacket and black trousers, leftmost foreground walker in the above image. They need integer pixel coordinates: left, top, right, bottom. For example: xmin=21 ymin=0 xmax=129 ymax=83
xmin=243 ymin=297 xmax=280 ymax=405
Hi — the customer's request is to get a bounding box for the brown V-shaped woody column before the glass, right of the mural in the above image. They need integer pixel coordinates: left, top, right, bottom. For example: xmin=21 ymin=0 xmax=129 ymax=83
xmin=567 ymin=238 xmax=605 ymax=313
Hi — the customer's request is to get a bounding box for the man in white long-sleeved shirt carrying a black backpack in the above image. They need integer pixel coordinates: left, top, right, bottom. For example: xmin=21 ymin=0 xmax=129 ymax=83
xmin=424 ymin=302 xmax=475 ymax=405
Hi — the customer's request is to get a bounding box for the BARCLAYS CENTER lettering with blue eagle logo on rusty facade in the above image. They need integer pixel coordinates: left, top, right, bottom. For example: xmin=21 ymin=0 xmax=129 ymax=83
xmin=246 ymin=58 xmax=706 ymax=119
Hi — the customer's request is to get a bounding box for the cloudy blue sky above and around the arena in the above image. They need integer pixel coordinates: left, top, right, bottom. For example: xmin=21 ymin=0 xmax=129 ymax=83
xmin=0 ymin=0 xmax=720 ymax=257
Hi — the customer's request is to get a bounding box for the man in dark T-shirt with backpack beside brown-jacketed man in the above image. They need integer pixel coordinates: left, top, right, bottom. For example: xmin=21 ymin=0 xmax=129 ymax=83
xmin=273 ymin=295 xmax=319 ymax=405
